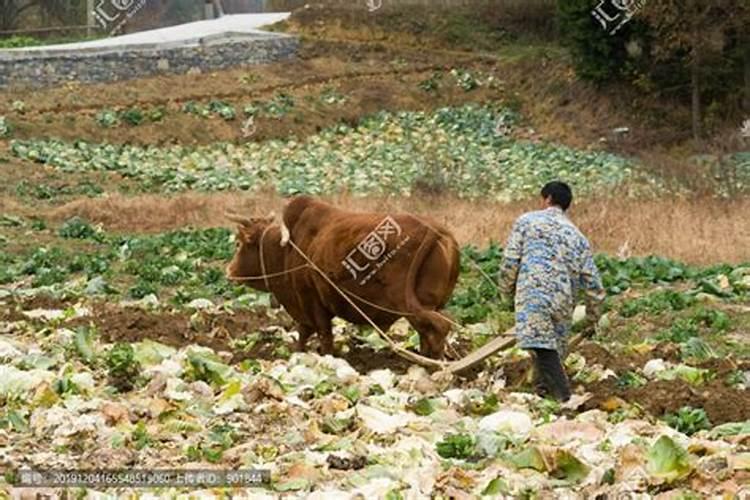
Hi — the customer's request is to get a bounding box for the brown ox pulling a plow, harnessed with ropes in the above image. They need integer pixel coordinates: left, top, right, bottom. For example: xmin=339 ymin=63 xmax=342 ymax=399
xmin=227 ymin=196 xmax=459 ymax=357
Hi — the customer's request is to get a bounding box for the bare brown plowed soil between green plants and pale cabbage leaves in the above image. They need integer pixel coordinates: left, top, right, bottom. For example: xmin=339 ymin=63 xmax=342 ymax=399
xmin=0 ymin=296 xmax=750 ymax=425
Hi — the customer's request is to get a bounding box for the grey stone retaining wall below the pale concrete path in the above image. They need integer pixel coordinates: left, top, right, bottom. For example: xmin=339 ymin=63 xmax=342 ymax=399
xmin=0 ymin=33 xmax=299 ymax=88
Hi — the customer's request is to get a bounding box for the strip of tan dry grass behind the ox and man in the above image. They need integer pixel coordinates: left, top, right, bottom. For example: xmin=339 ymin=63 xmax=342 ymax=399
xmin=42 ymin=194 xmax=750 ymax=264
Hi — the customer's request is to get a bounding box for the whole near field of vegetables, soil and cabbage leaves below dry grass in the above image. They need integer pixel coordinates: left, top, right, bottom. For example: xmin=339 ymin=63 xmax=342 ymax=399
xmin=0 ymin=217 xmax=750 ymax=499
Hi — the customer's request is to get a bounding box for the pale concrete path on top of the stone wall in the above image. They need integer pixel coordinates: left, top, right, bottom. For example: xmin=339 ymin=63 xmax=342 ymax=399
xmin=0 ymin=12 xmax=290 ymax=53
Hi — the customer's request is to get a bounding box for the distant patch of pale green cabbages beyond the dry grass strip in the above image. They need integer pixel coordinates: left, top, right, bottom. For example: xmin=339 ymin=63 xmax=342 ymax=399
xmin=11 ymin=105 xmax=659 ymax=201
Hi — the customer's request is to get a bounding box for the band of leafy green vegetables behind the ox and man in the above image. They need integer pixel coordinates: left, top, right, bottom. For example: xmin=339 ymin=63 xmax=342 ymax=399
xmin=0 ymin=219 xmax=750 ymax=312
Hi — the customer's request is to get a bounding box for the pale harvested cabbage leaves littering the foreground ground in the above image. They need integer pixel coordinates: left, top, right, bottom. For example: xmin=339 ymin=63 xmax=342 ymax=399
xmin=0 ymin=282 xmax=750 ymax=500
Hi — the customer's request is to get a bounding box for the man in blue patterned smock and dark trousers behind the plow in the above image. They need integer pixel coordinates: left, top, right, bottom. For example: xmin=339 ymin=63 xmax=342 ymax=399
xmin=500 ymin=182 xmax=605 ymax=401
